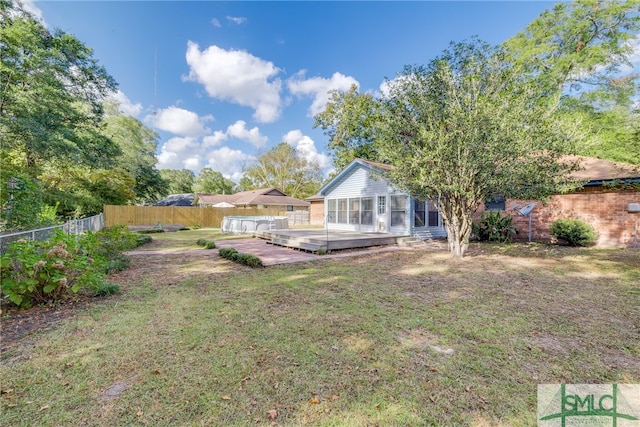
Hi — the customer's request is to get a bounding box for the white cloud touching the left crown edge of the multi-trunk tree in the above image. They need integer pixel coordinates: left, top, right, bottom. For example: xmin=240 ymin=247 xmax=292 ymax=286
xmin=287 ymin=71 xmax=359 ymax=117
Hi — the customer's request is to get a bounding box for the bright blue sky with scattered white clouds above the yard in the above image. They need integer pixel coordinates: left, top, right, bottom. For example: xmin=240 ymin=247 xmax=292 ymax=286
xmin=29 ymin=1 xmax=553 ymax=181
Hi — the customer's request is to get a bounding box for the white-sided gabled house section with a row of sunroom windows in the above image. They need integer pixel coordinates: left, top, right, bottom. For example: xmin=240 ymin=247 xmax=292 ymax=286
xmin=318 ymin=159 xmax=447 ymax=238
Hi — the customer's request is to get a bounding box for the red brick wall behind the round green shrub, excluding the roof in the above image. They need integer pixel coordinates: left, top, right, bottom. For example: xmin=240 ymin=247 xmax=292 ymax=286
xmin=478 ymin=191 xmax=640 ymax=247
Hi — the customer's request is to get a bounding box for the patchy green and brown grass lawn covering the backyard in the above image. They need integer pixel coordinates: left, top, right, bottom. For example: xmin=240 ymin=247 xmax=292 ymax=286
xmin=0 ymin=230 xmax=640 ymax=426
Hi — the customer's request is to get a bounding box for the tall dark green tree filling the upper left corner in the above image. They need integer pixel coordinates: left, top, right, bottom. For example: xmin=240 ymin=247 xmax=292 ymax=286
xmin=0 ymin=1 xmax=119 ymax=177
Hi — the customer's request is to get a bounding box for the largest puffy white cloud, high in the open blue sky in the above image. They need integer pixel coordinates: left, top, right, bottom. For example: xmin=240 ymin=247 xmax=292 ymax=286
xmin=183 ymin=41 xmax=282 ymax=123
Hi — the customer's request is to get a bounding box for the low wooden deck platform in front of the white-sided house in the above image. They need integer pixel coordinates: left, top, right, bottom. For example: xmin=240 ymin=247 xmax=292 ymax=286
xmin=255 ymin=229 xmax=407 ymax=252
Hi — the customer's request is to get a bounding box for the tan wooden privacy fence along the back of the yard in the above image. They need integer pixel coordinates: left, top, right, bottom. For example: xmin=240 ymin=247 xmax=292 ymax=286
xmin=104 ymin=205 xmax=280 ymax=227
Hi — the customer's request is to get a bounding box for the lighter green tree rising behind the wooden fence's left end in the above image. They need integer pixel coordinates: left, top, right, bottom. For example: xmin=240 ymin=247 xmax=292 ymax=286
xmin=104 ymin=102 xmax=168 ymax=202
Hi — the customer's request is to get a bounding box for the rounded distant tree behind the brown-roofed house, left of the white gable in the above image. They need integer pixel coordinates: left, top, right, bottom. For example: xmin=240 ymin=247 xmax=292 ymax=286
xmin=240 ymin=142 xmax=322 ymax=199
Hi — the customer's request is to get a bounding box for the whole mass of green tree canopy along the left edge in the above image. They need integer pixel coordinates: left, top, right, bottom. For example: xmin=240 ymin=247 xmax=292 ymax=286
xmin=0 ymin=0 xmax=166 ymax=230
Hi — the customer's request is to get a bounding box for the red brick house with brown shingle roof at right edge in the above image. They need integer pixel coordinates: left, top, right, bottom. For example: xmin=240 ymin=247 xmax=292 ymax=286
xmin=478 ymin=157 xmax=640 ymax=247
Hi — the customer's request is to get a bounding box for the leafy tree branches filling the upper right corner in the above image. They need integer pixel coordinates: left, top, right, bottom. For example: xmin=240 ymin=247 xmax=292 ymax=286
xmin=504 ymin=0 xmax=640 ymax=164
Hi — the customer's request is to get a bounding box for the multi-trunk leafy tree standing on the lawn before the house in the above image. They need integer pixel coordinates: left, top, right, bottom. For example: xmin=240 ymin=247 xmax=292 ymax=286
xmin=376 ymin=40 xmax=573 ymax=257
